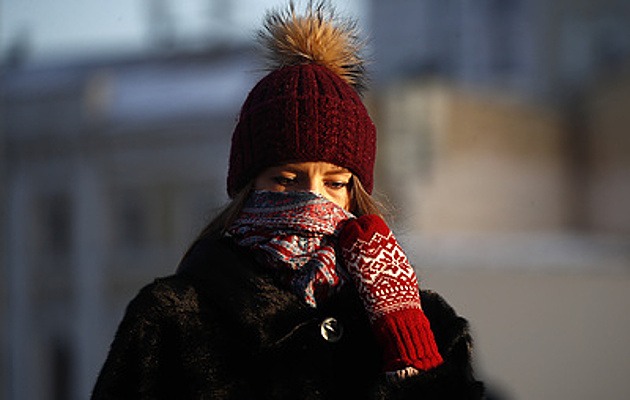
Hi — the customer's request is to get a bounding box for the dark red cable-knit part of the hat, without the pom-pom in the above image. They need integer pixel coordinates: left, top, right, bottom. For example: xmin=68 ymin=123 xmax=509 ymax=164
xmin=227 ymin=64 xmax=376 ymax=197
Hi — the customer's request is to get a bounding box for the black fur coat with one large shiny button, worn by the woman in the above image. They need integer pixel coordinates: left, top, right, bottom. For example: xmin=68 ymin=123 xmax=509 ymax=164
xmin=92 ymin=239 xmax=483 ymax=400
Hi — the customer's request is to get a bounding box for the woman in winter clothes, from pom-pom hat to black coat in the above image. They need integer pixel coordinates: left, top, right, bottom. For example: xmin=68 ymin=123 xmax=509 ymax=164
xmin=93 ymin=4 xmax=483 ymax=399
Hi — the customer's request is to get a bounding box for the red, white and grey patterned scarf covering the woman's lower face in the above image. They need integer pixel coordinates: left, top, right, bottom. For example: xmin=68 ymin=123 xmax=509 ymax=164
xmin=227 ymin=190 xmax=354 ymax=307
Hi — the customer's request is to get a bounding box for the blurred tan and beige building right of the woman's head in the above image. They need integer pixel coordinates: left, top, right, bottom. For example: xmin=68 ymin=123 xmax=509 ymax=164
xmin=376 ymin=72 xmax=630 ymax=271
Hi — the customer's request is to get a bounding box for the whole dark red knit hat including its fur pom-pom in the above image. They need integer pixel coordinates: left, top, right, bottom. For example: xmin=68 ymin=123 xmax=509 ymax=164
xmin=227 ymin=2 xmax=376 ymax=197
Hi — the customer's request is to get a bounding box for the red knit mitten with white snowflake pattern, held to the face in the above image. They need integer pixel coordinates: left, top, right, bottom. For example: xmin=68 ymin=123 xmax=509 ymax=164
xmin=339 ymin=215 xmax=442 ymax=371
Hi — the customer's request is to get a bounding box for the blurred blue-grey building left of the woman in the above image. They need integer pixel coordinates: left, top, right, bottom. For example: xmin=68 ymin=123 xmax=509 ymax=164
xmin=0 ymin=48 xmax=257 ymax=400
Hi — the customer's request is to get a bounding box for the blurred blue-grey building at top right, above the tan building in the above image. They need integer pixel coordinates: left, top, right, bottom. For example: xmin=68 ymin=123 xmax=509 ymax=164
xmin=370 ymin=0 xmax=630 ymax=103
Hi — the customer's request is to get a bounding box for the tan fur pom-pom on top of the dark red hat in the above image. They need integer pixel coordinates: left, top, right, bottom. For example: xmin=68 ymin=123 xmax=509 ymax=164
xmin=258 ymin=1 xmax=366 ymax=93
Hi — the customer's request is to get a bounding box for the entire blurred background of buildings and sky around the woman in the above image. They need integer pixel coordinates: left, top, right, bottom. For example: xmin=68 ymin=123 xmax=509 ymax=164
xmin=0 ymin=0 xmax=630 ymax=400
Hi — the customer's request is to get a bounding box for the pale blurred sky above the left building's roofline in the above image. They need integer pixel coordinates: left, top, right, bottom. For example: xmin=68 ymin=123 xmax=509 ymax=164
xmin=0 ymin=0 xmax=367 ymax=61
